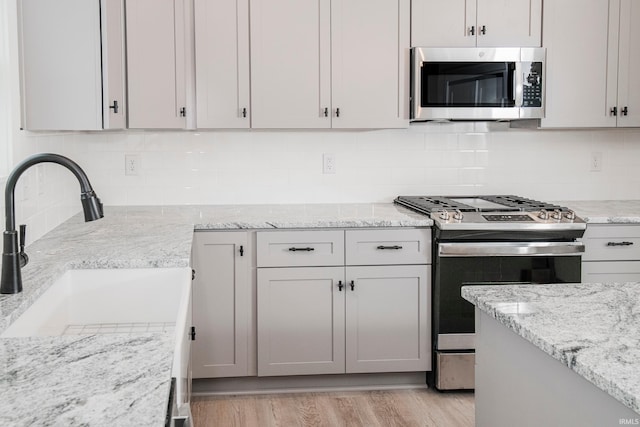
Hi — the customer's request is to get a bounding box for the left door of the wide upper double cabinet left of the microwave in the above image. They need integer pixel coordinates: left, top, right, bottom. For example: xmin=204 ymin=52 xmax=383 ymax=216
xmin=250 ymin=0 xmax=331 ymax=128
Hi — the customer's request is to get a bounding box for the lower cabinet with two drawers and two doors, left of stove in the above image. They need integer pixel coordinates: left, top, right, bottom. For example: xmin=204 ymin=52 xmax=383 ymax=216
xmin=256 ymin=229 xmax=431 ymax=376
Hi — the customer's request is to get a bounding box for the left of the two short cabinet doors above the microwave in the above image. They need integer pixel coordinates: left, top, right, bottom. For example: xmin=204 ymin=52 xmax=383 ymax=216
xmin=411 ymin=0 xmax=476 ymax=47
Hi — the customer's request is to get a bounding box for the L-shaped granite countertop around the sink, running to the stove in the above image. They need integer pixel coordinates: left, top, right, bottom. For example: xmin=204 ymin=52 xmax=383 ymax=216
xmin=0 ymin=203 xmax=433 ymax=427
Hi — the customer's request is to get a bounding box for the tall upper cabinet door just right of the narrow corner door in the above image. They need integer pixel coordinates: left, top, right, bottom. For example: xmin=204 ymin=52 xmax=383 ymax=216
xmin=126 ymin=0 xmax=186 ymax=128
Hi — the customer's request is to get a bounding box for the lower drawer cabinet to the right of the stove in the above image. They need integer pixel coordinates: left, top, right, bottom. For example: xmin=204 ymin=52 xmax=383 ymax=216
xmin=582 ymin=224 xmax=640 ymax=283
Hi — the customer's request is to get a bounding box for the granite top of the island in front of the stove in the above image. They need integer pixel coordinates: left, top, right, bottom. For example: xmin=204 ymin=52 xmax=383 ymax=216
xmin=462 ymin=282 xmax=640 ymax=414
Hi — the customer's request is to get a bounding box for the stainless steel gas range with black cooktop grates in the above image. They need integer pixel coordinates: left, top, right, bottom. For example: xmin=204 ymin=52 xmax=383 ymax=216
xmin=395 ymin=196 xmax=586 ymax=390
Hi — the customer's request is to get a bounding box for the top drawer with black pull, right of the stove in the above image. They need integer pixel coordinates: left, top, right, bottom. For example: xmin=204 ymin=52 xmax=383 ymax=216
xmin=582 ymin=225 xmax=640 ymax=261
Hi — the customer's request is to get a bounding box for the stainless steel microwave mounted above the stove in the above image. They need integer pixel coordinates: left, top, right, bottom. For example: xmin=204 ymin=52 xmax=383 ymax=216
xmin=411 ymin=47 xmax=546 ymax=121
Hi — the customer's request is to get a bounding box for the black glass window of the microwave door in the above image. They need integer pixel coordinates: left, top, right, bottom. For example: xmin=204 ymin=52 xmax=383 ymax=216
xmin=420 ymin=62 xmax=516 ymax=108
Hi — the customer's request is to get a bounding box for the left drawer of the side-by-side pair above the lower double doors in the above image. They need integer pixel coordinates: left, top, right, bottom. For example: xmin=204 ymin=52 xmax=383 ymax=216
xmin=256 ymin=231 xmax=344 ymax=267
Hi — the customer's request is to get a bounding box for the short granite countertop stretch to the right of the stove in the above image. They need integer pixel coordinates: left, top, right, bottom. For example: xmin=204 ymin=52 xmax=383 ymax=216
xmin=554 ymin=200 xmax=640 ymax=224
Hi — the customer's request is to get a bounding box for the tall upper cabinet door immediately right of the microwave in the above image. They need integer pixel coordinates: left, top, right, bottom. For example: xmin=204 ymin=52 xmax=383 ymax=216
xmin=541 ymin=0 xmax=619 ymax=128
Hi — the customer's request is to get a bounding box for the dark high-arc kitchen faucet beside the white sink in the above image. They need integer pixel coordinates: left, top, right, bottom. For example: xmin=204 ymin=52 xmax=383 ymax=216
xmin=0 ymin=153 xmax=104 ymax=294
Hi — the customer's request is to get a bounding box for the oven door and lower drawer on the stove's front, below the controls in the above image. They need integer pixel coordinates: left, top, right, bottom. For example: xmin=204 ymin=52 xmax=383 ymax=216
xmin=433 ymin=242 xmax=584 ymax=390
